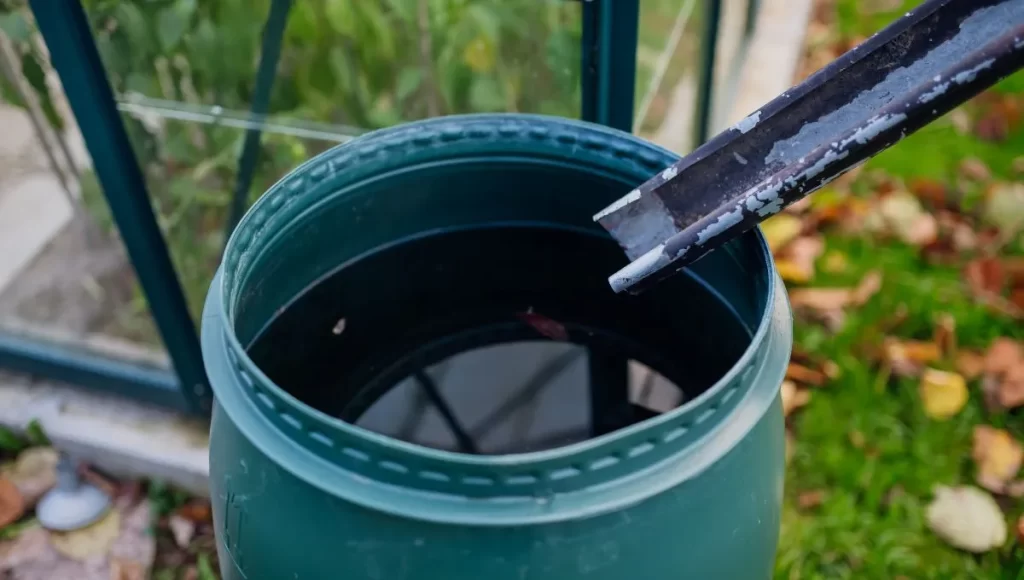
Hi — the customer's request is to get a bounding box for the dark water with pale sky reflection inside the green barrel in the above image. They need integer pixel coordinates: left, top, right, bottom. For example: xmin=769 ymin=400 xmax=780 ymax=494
xmin=243 ymin=226 xmax=751 ymax=454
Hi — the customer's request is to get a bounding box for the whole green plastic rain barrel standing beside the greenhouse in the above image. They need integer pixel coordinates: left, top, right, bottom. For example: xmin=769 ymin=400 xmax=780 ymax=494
xmin=202 ymin=115 xmax=792 ymax=580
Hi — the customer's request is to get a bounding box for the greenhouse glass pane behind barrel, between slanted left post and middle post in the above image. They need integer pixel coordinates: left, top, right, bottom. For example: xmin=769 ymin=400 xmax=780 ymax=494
xmin=75 ymin=0 xmax=582 ymax=329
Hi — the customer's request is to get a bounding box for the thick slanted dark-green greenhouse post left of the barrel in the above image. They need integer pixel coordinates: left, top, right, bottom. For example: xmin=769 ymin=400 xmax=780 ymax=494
xmin=30 ymin=0 xmax=212 ymax=413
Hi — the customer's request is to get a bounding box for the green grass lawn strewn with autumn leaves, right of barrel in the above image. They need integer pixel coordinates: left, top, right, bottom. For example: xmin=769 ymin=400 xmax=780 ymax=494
xmin=776 ymin=0 xmax=1024 ymax=579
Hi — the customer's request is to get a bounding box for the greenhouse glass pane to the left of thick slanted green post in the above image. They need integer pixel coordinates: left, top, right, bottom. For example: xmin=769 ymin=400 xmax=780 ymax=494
xmin=0 ymin=39 xmax=167 ymax=367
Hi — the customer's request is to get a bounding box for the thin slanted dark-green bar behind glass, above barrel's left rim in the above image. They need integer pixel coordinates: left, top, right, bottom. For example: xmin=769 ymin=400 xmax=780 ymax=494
xmin=224 ymin=0 xmax=292 ymax=243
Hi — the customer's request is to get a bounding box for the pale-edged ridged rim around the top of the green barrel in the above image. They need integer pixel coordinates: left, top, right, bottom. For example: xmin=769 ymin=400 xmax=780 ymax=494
xmin=203 ymin=115 xmax=790 ymax=516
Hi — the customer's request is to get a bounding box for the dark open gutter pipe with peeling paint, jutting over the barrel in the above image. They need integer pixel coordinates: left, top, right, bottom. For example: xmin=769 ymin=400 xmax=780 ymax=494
xmin=594 ymin=0 xmax=1024 ymax=292
